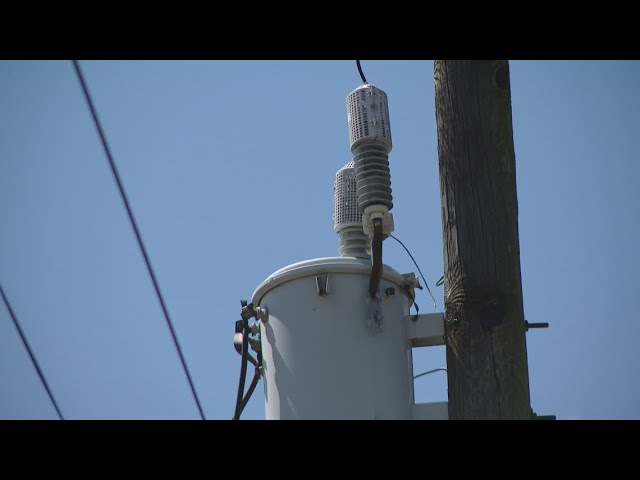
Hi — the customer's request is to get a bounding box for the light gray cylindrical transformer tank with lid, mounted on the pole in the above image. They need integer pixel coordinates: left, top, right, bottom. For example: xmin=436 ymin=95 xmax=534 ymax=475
xmin=252 ymin=257 xmax=413 ymax=419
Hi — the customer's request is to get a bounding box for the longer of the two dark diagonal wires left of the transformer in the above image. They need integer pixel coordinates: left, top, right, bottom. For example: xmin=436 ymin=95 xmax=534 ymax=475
xmin=72 ymin=60 xmax=205 ymax=420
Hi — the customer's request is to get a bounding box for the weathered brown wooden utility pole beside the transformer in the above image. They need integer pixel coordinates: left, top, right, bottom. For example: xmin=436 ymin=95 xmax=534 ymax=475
xmin=434 ymin=60 xmax=531 ymax=420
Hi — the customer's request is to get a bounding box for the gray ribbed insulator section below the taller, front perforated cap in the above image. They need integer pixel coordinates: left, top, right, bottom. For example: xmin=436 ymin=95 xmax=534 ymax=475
xmin=353 ymin=143 xmax=393 ymax=213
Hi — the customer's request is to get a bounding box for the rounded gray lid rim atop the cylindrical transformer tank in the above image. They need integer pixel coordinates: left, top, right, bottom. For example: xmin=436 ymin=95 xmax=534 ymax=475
xmin=251 ymin=257 xmax=408 ymax=305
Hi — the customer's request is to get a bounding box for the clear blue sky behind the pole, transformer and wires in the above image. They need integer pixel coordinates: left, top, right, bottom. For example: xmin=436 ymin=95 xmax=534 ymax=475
xmin=0 ymin=60 xmax=640 ymax=419
